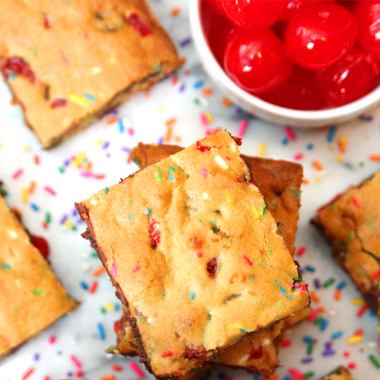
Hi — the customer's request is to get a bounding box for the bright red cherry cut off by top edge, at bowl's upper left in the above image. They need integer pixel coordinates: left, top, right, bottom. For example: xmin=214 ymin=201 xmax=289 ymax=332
xmin=220 ymin=0 xmax=288 ymax=30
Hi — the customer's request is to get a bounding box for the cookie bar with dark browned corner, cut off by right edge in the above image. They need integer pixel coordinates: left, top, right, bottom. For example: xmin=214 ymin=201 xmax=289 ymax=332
xmin=312 ymin=171 xmax=380 ymax=316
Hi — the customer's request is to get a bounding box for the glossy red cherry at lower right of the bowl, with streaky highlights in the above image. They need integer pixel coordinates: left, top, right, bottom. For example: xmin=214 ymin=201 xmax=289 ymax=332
xmin=316 ymin=47 xmax=379 ymax=106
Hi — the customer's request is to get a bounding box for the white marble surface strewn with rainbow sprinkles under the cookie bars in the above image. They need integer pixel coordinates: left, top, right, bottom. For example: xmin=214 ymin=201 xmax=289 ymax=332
xmin=0 ymin=0 xmax=380 ymax=380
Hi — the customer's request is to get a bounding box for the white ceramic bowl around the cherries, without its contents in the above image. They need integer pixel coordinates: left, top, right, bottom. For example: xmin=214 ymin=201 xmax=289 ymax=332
xmin=189 ymin=0 xmax=380 ymax=127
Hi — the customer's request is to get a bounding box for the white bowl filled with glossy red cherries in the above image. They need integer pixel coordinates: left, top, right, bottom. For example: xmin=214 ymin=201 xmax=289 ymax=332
xmin=190 ymin=0 xmax=380 ymax=127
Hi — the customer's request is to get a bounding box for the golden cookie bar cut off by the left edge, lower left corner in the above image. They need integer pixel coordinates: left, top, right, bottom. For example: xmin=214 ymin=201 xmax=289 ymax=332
xmin=0 ymin=196 xmax=77 ymax=358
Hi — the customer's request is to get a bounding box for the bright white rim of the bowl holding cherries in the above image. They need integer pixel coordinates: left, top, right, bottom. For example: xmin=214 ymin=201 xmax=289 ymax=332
xmin=189 ymin=0 xmax=380 ymax=125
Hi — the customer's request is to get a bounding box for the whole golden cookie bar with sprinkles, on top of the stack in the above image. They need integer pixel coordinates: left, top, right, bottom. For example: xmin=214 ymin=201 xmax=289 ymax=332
xmin=77 ymin=132 xmax=309 ymax=377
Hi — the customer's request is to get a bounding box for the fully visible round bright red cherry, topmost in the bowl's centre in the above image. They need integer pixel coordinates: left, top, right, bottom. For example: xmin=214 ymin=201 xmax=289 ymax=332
xmin=285 ymin=2 xmax=357 ymax=70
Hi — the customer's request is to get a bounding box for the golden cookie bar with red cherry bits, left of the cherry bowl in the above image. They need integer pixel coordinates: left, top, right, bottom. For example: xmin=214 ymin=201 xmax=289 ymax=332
xmin=0 ymin=0 xmax=179 ymax=148
